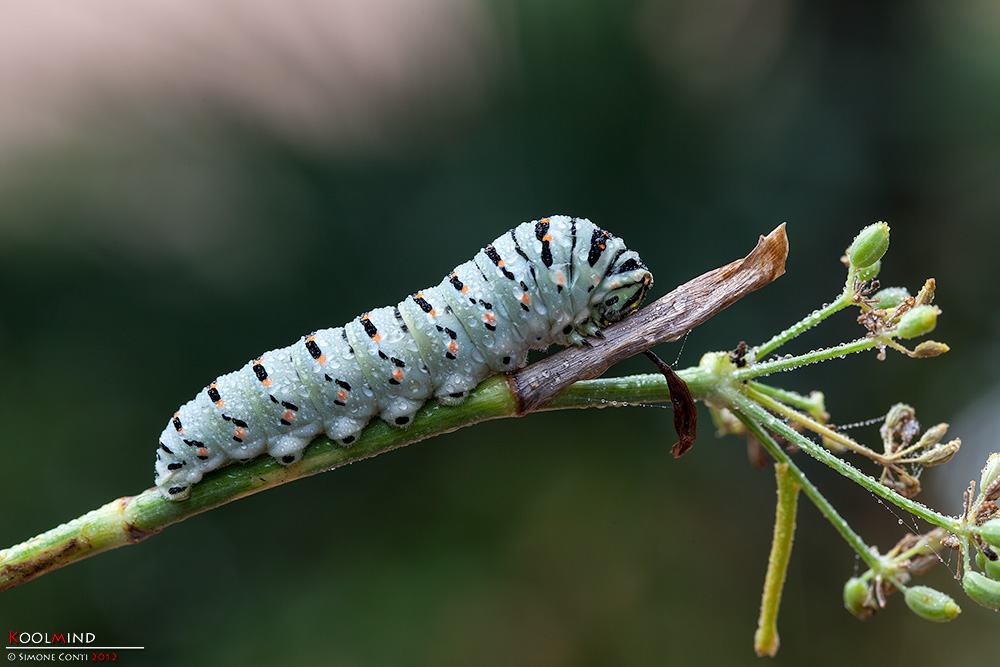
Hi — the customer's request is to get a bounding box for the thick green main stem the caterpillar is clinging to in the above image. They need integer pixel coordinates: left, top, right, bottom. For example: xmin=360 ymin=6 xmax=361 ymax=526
xmin=0 ymin=368 xmax=688 ymax=591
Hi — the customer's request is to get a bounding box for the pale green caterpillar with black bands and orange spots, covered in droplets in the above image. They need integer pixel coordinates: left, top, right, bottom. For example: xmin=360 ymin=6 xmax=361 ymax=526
xmin=154 ymin=215 xmax=653 ymax=500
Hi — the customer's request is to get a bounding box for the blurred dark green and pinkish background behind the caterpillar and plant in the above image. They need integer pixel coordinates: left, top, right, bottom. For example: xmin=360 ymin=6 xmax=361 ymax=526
xmin=0 ymin=0 xmax=1000 ymax=666
